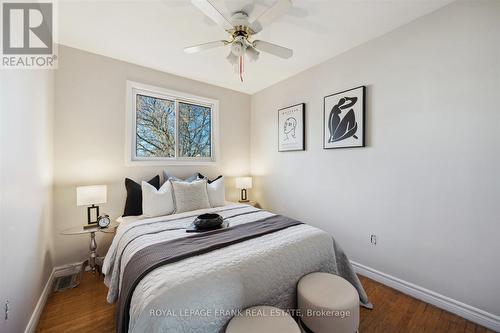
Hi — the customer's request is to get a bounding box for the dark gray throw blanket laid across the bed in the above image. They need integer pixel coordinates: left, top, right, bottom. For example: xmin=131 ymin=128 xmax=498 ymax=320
xmin=116 ymin=215 xmax=302 ymax=332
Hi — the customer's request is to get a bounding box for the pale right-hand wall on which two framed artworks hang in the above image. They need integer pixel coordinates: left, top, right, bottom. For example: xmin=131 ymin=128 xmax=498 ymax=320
xmin=251 ymin=1 xmax=500 ymax=315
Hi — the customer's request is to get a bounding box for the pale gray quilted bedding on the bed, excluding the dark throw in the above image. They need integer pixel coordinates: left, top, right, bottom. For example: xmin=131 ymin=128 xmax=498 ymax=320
xmin=103 ymin=204 xmax=371 ymax=332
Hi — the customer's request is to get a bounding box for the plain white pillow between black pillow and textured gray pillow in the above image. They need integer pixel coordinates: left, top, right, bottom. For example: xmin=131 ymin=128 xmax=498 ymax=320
xmin=141 ymin=181 xmax=175 ymax=217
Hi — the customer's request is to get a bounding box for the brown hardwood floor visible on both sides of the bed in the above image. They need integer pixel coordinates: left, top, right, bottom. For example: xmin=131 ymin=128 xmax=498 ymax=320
xmin=37 ymin=273 xmax=493 ymax=333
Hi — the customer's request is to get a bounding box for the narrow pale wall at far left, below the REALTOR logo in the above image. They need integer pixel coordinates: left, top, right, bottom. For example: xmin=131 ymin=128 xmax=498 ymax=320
xmin=0 ymin=70 xmax=54 ymax=332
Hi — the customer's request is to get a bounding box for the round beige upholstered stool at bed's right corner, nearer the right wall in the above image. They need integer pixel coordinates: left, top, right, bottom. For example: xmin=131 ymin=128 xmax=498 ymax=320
xmin=297 ymin=273 xmax=359 ymax=333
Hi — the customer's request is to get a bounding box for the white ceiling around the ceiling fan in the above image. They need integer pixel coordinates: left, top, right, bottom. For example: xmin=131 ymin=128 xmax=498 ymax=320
xmin=58 ymin=0 xmax=451 ymax=94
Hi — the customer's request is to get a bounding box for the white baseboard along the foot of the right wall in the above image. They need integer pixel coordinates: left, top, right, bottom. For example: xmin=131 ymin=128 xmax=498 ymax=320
xmin=351 ymin=261 xmax=500 ymax=332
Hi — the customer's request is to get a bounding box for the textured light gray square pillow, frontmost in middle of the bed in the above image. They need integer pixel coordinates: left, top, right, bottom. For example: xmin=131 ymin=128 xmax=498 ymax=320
xmin=170 ymin=179 xmax=210 ymax=213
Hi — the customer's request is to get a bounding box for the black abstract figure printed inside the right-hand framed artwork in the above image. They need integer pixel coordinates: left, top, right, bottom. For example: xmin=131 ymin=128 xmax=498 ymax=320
xmin=328 ymin=97 xmax=358 ymax=143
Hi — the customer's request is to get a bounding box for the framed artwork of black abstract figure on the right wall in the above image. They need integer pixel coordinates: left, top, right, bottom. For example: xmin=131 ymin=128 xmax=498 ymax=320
xmin=323 ymin=86 xmax=365 ymax=149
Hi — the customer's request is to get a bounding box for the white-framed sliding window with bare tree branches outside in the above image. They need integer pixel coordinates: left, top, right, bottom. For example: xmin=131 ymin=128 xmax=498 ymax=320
xmin=126 ymin=81 xmax=218 ymax=164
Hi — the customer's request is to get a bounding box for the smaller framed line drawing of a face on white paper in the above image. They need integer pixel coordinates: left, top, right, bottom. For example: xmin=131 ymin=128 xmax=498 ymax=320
xmin=278 ymin=103 xmax=305 ymax=151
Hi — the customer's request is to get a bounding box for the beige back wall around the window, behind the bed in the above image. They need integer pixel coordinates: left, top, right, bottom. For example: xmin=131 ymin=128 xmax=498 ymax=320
xmin=54 ymin=46 xmax=250 ymax=265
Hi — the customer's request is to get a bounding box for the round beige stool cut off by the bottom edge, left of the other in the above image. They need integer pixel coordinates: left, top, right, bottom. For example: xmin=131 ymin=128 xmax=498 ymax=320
xmin=226 ymin=305 xmax=300 ymax=333
